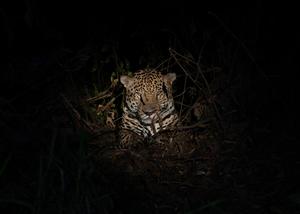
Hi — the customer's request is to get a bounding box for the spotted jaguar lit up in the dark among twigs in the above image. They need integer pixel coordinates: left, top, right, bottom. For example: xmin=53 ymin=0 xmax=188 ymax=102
xmin=120 ymin=69 xmax=179 ymax=148
